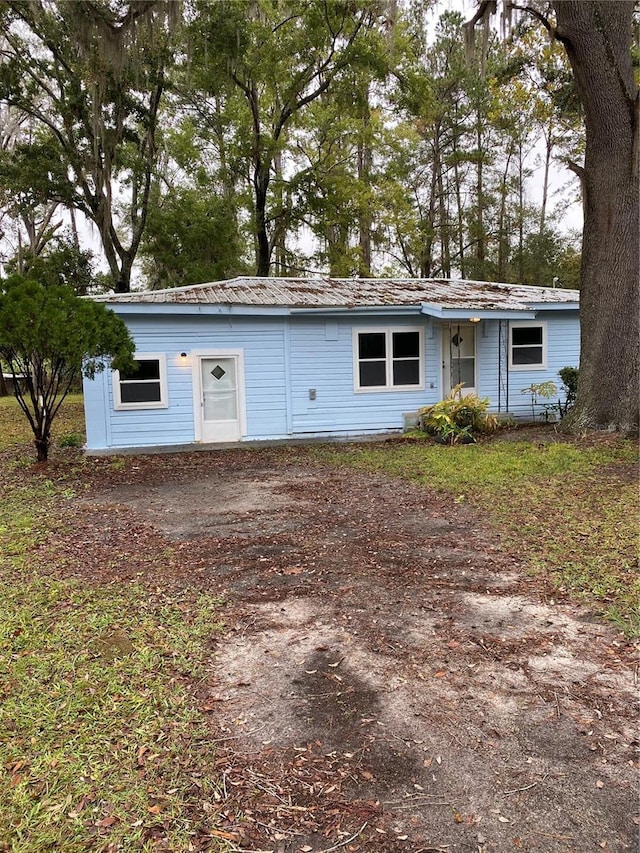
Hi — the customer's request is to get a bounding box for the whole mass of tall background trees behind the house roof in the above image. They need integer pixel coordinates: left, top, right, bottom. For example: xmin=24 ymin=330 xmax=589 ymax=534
xmin=0 ymin=0 xmax=582 ymax=291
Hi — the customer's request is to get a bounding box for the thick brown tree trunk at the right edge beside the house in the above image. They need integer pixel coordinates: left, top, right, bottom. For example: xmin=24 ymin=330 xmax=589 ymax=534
xmin=553 ymin=0 xmax=640 ymax=433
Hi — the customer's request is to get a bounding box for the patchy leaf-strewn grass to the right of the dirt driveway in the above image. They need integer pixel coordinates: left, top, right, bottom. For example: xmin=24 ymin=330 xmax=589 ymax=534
xmin=308 ymin=436 xmax=640 ymax=637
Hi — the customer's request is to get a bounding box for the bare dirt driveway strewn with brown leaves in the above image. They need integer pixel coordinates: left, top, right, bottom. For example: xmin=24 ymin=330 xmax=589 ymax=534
xmin=86 ymin=451 xmax=638 ymax=853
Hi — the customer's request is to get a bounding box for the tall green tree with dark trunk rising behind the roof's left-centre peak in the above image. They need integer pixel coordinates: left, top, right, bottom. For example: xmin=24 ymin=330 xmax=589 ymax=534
xmin=184 ymin=0 xmax=386 ymax=275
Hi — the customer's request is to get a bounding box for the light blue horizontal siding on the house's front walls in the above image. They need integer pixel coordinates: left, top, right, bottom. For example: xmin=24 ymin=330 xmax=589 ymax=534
xmin=85 ymin=306 xmax=579 ymax=450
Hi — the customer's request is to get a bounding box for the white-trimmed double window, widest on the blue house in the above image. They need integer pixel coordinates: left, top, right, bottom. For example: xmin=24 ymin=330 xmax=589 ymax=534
xmin=353 ymin=328 xmax=424 ymax=391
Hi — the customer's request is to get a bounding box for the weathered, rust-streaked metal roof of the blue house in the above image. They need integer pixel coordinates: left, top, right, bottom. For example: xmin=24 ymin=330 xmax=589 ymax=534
xmin=94 ymin=276 xmax=579 ymax=312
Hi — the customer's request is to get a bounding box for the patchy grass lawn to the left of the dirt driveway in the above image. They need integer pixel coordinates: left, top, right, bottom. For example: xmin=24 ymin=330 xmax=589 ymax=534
xmin=0 ymin=398 xmax=226 ymax=853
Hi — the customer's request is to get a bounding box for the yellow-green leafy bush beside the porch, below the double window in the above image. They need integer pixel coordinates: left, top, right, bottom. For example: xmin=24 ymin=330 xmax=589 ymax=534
xmin=418 ymin=383 xmax=497 ymax=444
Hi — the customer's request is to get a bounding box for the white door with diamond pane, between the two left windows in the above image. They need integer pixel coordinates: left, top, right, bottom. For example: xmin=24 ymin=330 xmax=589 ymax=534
xmin=194 ymin=353 xmax=244 ymax=442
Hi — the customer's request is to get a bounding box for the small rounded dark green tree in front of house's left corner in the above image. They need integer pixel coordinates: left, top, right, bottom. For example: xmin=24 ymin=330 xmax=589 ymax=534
xmin=0 ymin=275 xmax=135 ymax=462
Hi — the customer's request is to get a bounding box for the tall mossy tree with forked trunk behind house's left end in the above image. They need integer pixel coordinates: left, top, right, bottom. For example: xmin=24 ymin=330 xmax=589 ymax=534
xmin=0 ymin=0 xmax=177 ymax=292
